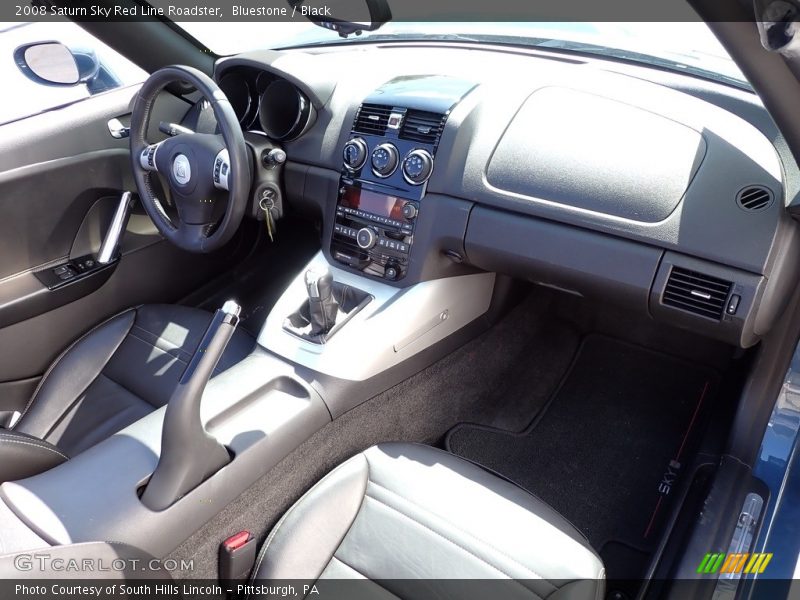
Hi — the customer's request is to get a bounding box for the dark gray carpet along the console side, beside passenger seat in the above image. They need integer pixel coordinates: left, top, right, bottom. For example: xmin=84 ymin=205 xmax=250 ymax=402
xmin=169 ymin=293 xmax=580 ymax=578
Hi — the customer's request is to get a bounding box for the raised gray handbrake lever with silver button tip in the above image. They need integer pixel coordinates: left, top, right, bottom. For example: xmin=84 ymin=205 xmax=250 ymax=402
xmin=142 ymin=300 xmax=241 ymax=510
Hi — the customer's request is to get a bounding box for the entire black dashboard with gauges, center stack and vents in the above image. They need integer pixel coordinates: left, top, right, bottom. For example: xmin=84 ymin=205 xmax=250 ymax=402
xmin=209 ymin=43 xmax=800 ymax=346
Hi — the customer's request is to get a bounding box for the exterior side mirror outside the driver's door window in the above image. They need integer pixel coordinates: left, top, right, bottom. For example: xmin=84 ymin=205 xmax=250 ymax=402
xmin=14 ymin=41 xmax=100 ymax=87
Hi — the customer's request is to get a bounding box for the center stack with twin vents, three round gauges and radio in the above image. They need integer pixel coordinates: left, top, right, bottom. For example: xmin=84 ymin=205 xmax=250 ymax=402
xmin=330 ymin=76 xmax=474 ymax=281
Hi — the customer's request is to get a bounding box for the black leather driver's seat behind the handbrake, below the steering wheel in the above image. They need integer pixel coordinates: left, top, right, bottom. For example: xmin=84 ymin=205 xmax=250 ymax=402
xmin=0 ymin=305 xmax=255 ymax=482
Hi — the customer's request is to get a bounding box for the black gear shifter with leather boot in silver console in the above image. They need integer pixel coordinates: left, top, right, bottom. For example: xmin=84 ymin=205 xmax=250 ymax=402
xmin=283 ymin=271 xmax=372 ymax=344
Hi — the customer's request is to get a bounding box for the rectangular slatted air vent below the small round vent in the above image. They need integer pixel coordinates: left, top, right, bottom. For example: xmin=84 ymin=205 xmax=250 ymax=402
xmin=662 ymin=267 xmax=731 ymax=321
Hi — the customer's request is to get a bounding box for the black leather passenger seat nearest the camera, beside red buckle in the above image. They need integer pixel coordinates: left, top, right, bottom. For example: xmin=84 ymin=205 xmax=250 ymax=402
xmin=251 ymin=443 xmax=605 ymax=599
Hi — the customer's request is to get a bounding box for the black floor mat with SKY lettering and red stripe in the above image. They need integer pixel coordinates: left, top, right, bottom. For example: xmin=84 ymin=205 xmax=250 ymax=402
xmin=445 ymin=335 xmax=718 ymax=578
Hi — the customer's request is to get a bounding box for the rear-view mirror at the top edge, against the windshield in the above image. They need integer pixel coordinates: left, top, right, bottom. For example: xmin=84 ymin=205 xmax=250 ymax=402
xmin=289 ymin=0 xmax=392 ymax=37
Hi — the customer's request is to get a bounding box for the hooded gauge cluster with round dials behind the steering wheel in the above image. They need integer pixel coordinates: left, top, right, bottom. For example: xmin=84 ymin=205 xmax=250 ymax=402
xmin=218 ymin=66 xmax=316 ymax=142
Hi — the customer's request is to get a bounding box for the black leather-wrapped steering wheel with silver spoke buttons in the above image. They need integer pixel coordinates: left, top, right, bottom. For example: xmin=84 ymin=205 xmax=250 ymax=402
xmin=130 ymin=66 xmax=251 ymax=252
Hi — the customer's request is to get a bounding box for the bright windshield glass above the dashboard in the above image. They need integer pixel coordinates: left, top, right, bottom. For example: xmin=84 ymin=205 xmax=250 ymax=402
xmin=179 ymin=22 xmax=749 ymax=87
